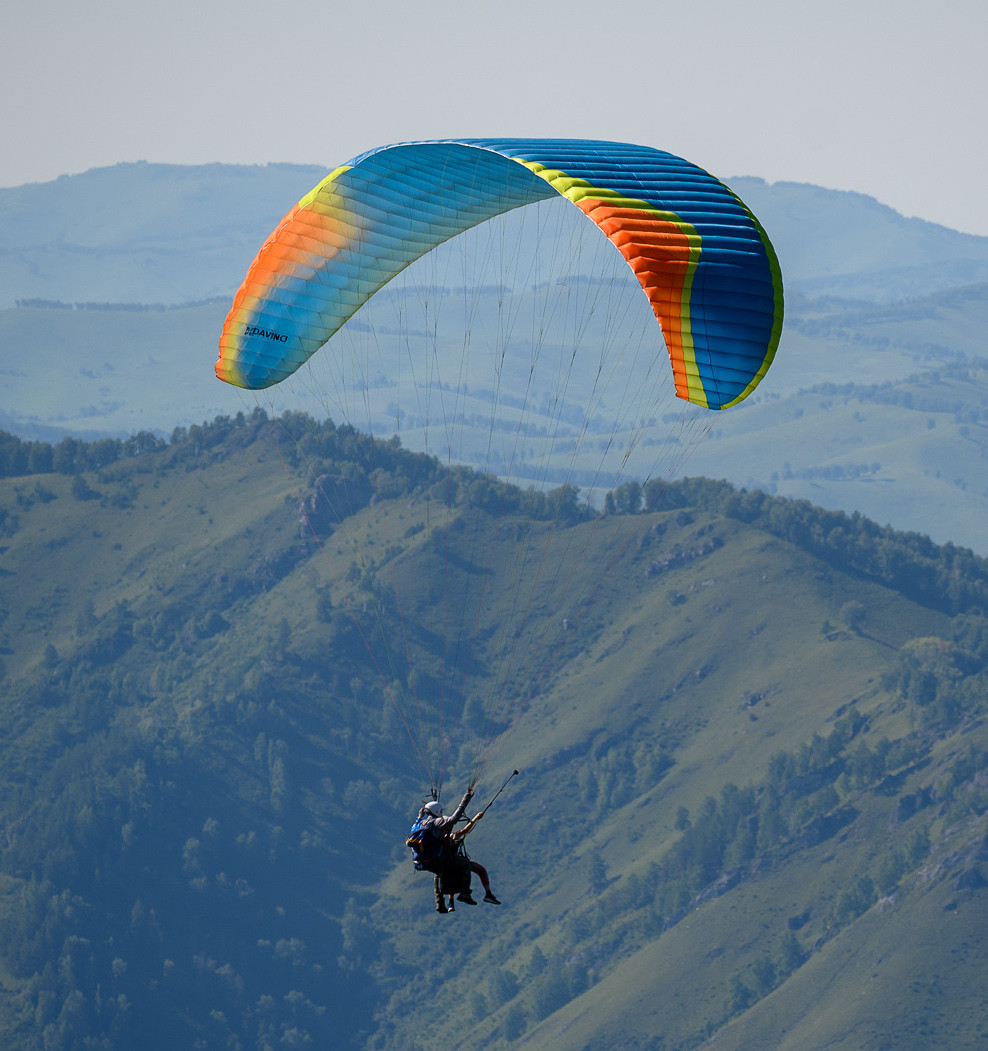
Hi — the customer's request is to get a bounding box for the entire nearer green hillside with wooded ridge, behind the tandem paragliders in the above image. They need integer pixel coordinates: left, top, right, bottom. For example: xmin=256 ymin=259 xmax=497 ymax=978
xmin=0 ymin=413 xmax=988 ymax=1051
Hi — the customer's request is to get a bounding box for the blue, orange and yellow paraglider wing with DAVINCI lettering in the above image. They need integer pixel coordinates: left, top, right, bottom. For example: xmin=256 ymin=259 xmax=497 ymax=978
xmin=215 ymin=139 xmax=783 ymax=409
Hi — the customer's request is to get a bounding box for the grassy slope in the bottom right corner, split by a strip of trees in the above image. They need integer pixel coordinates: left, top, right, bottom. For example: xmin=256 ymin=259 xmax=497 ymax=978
xmin=517 ymin=819 xmax=986 ymax=1051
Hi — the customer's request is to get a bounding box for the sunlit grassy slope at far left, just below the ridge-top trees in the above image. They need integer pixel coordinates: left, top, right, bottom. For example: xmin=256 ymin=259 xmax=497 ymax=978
xmin=0 ymin=426 xmax=290 ymax=675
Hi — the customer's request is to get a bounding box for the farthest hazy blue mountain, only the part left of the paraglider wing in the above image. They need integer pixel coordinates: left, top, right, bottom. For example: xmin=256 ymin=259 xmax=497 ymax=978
xmin=0 ymin=163 xmax=326 ymax=308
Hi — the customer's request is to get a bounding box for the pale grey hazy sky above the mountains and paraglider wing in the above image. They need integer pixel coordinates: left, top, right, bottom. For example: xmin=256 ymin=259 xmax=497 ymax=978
xmin=7 ymin=0 xmax=988 ymax=234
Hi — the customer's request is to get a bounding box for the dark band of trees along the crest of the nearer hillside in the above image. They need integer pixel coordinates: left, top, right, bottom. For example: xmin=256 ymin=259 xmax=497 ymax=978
xmin=7 ymin=408 xmax=988 ymax=615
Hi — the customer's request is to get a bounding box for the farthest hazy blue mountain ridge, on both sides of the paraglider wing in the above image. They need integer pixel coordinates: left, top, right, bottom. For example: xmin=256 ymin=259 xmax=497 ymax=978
xmin=0 ymin=163 xmax=988 ymax=309
